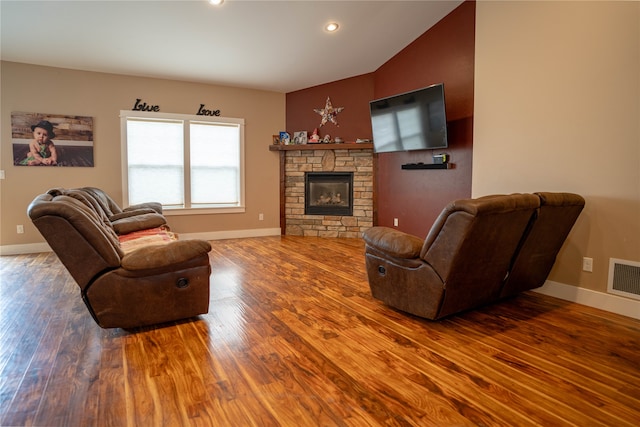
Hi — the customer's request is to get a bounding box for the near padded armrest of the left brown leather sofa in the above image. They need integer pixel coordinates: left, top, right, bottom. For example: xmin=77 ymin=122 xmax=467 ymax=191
xmin=121 ymin=240 xmax=211 ymax=271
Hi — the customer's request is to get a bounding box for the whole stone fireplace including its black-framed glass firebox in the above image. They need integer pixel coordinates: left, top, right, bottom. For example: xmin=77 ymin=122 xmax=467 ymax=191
xmin=280 ymin=149 xmax=373 ymax=238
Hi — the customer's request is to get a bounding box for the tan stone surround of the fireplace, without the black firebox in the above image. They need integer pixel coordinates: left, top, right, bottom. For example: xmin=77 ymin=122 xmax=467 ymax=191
xmin=284 ymin=148 xmax=373 ymax=238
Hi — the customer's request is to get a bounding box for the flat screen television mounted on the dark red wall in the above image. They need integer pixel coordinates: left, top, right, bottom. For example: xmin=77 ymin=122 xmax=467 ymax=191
xmin=369 ymin=83 xmax=448 ymax=153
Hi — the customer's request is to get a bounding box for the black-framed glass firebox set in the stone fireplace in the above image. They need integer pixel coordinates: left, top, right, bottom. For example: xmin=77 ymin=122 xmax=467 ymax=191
xmin=304 ymin=172 xmax=353 ymax=216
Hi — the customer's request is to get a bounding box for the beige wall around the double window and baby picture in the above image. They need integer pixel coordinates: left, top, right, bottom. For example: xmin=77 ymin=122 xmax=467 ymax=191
xmin=0 ymin=62 xmax=285 ymax=247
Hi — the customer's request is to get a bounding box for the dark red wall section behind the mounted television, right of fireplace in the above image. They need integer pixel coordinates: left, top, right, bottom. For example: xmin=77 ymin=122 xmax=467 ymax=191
xmin=374 ymin=2 xmax=475 ymax=237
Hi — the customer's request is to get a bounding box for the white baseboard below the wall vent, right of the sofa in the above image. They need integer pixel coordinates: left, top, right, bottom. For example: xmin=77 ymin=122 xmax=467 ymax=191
xmin=534 ymin=280 xmax=640 ymax=319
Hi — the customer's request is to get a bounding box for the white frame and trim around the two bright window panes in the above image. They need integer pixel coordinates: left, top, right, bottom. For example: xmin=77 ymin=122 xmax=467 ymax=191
xmin=120 ymin=110 xmax=246 ymax=216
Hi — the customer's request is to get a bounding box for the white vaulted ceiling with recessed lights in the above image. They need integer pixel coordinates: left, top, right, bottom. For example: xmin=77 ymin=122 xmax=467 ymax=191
xmin=0 ymin=0 xmax=462 ymax=92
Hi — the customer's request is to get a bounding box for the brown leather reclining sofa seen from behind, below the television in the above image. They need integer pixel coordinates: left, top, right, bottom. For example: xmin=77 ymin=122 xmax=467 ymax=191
xmin=363 ymin=193 xmax=585 ymax=320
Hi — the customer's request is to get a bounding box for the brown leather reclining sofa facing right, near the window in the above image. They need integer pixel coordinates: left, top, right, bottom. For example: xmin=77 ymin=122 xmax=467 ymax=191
xmin=27 ymin=187 xmax=211 ymax=329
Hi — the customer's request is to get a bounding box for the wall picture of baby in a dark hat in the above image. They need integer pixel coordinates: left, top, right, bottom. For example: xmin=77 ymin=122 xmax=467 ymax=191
xmin=11 ymin=112 xmax=94 ymax=167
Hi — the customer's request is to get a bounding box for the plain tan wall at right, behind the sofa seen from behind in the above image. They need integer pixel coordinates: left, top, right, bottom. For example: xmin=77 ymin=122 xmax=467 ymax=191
xmin=472 ymin=1 xmax=640 ymax=292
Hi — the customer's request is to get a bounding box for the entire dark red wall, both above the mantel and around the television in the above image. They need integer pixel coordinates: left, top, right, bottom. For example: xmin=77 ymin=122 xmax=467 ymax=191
xmin=286 ymin=1 xmax=475 ymax=237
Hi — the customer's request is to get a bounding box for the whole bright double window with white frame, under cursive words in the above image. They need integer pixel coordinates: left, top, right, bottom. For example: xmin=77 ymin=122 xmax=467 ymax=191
xmin=120 ymin=111 xmax=244 ymax=213
